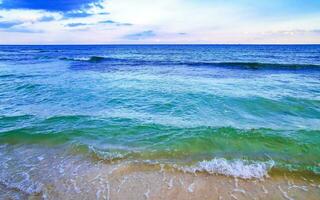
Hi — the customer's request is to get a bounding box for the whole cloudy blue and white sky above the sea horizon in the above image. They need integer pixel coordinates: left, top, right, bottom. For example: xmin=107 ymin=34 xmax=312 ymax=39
xmin=0 ymin=0 xmax=320 ymax=44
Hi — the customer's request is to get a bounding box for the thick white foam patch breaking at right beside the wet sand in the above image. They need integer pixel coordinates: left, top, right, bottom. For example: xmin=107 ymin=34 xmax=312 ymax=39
xmin=179 ymin=158 xmax=274 ymax=179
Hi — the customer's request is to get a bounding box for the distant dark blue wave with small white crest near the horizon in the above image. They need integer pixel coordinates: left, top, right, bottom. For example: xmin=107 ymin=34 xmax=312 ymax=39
xmin=60 ymin=56 xmax=320 ymax=70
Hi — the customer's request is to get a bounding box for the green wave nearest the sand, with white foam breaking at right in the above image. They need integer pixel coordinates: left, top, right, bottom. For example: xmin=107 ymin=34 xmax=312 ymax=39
xmin=0 ymin=115 xmax=320 ymax=178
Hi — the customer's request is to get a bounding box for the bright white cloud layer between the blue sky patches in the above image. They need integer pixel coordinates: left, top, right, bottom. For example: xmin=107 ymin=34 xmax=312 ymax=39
xmin=0 ymin=0 xmax=320 ymax=43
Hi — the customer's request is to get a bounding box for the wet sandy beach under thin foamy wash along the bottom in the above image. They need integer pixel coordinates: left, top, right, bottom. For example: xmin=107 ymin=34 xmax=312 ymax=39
xmin=0 ymin=145 xmax=320 ymax=200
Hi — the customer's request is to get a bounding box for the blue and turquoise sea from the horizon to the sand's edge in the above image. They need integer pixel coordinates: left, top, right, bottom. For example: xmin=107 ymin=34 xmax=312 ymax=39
xmin=0 ymin=45 xmax=320 ymax=178
